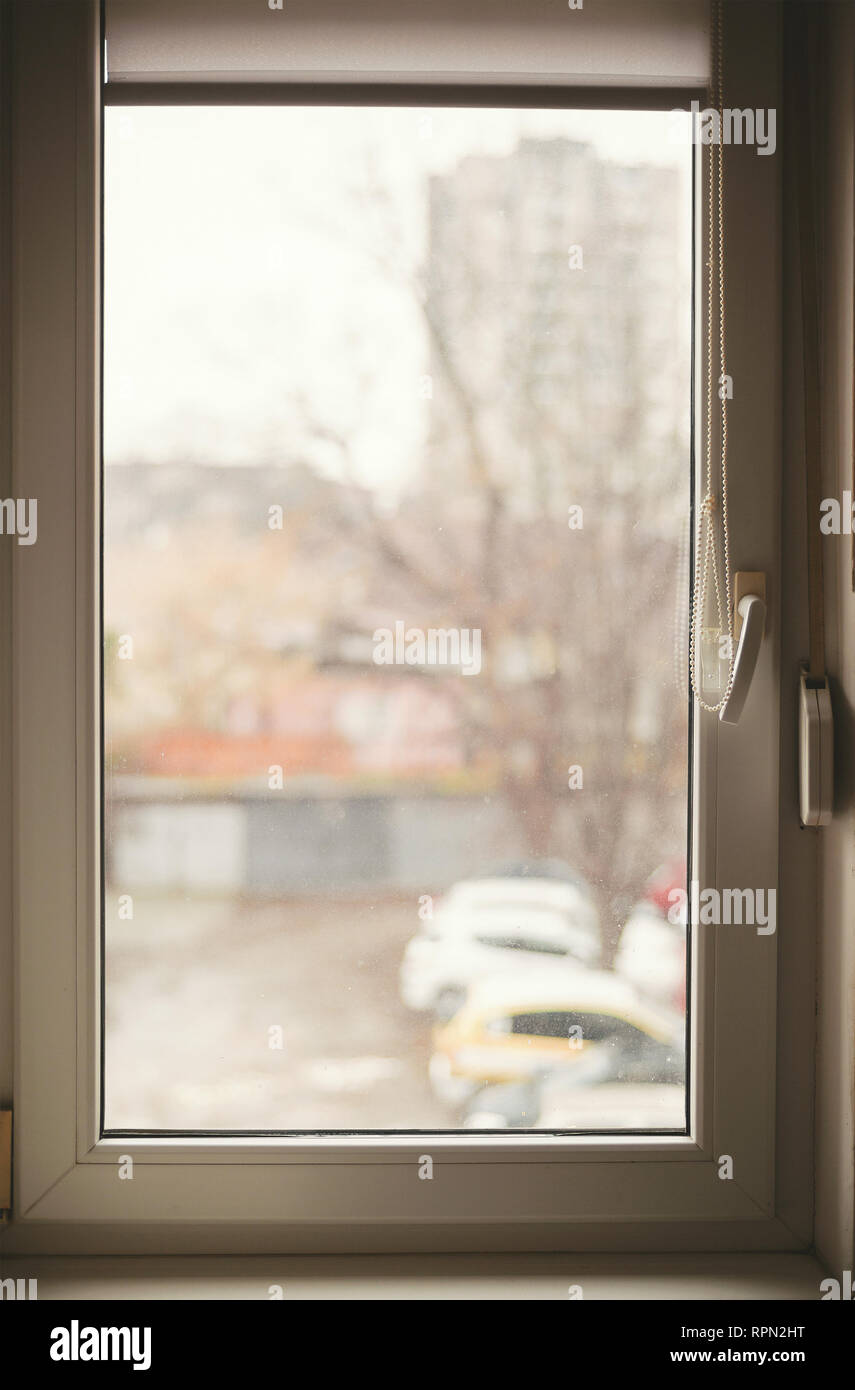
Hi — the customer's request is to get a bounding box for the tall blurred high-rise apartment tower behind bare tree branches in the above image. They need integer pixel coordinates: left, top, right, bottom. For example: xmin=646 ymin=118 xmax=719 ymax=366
xmin=428 ymin=138 xmax=691 ymax=524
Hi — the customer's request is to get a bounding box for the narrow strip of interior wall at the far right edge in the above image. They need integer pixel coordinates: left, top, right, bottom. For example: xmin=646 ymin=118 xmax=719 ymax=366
xmin=805 ymin=3 xmax=855 ymax=1272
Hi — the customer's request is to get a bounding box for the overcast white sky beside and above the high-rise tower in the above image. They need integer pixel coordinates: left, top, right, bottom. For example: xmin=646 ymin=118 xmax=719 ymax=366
xmin=104 ymin=107 xmax=690 ymax=491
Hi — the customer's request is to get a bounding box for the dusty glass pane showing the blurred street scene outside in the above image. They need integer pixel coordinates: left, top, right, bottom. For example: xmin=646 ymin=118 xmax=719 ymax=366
xmin=103 ymin=107 xmax=692 ymax=1131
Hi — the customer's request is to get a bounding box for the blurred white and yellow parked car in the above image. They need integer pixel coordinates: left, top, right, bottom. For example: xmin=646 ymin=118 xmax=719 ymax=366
xmin=430 ymin=966 xmax=684 ymax=1105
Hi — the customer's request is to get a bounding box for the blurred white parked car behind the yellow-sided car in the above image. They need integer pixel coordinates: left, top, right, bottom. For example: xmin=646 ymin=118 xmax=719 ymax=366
xmin=400 ymin=877 xmax=599 ymax=1019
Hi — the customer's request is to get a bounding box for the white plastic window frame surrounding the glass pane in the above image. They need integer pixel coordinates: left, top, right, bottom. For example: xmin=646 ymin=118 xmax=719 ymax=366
xmin=7 ymin=0 xmax=813 ymax=1254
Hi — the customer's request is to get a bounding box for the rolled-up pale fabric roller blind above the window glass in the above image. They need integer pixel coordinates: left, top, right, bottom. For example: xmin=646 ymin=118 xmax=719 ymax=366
xmin=106 ymin=0 xmax=709 ymax=89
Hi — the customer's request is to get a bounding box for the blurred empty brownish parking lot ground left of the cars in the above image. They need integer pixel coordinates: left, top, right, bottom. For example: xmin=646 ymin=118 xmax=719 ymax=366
xmin=106 ymin=895 xmax=455 ymax=1129
